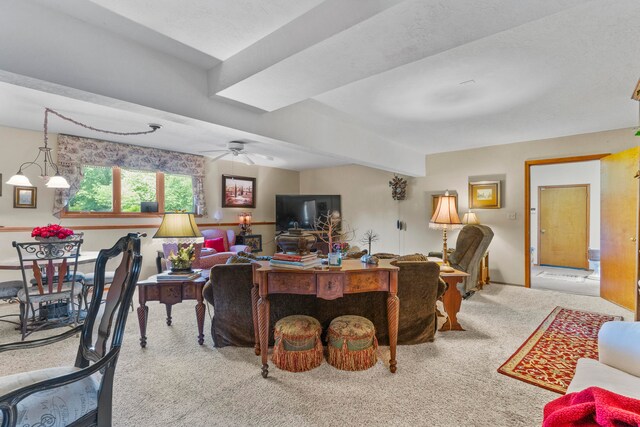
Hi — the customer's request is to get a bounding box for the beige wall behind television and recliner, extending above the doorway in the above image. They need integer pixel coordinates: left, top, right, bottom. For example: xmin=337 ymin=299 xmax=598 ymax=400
xmin=300 ymin=129 xmax=640 ymax=285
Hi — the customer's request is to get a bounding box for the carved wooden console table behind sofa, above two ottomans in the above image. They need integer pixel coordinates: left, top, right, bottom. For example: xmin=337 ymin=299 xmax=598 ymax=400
xmin=251 ymin=260 xmax=400 ymax=378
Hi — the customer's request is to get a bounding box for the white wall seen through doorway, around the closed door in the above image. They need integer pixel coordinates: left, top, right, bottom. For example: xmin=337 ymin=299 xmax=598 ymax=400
xmin=530 ymin=161 xmax=600 ymax=262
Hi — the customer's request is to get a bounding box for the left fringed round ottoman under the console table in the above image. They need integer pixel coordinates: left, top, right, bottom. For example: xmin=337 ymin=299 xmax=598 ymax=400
xmin=271 ymin=315 xmax=323 ymax=372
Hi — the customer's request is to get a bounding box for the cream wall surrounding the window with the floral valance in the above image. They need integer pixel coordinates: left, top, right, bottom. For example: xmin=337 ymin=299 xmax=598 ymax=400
xmin=0 ymin=126 xmax=299 ymax=281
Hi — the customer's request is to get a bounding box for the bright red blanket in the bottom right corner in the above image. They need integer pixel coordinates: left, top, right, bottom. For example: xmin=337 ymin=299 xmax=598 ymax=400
xmin=542 ymin=387 xmax=640 ymax=427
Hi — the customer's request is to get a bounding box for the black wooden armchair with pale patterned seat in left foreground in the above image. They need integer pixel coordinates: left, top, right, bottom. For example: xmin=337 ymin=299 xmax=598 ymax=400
xmin=0 ymin=233 xmax=144 ymax=427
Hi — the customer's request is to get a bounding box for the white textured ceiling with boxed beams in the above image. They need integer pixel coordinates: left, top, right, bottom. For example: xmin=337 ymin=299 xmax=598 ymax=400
xmin=0 ymin=0 xmax=640 ymax=175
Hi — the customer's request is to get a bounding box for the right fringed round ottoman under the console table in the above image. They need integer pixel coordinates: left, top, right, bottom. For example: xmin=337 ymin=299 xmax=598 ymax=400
xmin=327 ymin=316 xmax=378 ymax=371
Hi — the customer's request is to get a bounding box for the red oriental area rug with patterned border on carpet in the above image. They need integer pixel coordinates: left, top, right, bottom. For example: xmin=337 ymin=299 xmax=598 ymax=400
xmin=498 ymin=307 xmax=622 ymax=393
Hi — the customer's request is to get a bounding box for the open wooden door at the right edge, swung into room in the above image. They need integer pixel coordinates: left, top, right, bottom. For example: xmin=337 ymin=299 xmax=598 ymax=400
xmin=600 ymin=147 xmax=640 ymax=319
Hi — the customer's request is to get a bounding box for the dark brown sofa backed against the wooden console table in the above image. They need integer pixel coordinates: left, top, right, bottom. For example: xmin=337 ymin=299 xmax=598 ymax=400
xmin=203 ymin=261 xmax=446 ymax=347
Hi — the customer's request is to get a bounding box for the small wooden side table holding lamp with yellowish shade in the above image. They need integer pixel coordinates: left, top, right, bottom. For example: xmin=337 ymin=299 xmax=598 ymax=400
xmin=138 ymin=276 xmax=207 ymax=348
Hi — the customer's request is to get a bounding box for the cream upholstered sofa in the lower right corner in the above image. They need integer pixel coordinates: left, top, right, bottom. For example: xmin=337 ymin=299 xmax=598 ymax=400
xmin=567 ymin=322 xmax=640 ymax=399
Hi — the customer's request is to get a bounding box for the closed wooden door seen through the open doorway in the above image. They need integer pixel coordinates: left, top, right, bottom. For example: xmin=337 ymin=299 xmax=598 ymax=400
xmin=538 ymin=184 xmax=589 ymax=269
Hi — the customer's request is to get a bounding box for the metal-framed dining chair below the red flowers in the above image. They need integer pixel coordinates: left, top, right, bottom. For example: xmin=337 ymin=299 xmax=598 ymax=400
xmin=13 ymin=236 xmax=83 ymax=340
